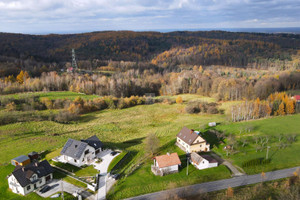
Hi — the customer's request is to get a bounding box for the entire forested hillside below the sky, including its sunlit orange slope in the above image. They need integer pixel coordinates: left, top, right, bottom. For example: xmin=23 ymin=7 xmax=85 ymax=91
xmin=0 ymin=31 xmax=300 ymax=77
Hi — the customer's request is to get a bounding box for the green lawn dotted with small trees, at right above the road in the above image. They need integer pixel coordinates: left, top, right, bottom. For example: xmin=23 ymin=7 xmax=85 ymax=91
xmin=215 ymin=114 xmax=300 ymax=174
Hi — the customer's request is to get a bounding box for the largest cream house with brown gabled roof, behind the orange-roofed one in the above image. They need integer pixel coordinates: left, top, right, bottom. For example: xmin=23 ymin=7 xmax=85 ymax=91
xmin=176 ymin=127 xmax=210 ymax=153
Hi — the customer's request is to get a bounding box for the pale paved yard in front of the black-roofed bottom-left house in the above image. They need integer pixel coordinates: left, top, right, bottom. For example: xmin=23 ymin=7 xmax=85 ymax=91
xmin=36 ymin=179 xmax=95 ymax=200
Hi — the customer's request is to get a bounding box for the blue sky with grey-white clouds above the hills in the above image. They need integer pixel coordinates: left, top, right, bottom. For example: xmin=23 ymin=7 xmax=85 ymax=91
xmin=0 ymin=0 xmax=300 ymax=34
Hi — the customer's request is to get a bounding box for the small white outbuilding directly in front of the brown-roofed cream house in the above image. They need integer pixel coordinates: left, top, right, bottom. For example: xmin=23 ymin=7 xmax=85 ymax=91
xmin=189 ymin=152 xmax=218 ymax=169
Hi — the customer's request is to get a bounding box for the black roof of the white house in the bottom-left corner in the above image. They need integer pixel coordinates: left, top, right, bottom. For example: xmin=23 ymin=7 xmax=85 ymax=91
xmin=12 ymin=160 xmax=53 ymax=187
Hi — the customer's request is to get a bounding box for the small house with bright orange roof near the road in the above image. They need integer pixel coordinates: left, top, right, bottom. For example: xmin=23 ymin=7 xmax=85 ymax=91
xmin=151 ymin=153 xmax=181 ymax=176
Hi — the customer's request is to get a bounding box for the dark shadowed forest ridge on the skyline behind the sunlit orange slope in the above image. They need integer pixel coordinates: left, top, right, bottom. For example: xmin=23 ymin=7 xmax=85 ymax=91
xmin=0 ymin=31 xmax=300 ymax=62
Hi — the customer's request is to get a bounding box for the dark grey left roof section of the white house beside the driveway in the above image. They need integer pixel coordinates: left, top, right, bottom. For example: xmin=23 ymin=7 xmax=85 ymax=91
xmin=60 ymin=139 xmax=88 ymax=159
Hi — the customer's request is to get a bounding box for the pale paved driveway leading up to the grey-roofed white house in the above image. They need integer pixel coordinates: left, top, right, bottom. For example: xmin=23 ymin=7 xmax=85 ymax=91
xmin=93 ymin=149 xmax=120 ymax=200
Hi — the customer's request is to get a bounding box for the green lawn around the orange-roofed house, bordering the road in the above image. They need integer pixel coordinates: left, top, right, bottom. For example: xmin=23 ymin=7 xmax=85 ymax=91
xmin=108 ymin=145 xmax=231 ymax=199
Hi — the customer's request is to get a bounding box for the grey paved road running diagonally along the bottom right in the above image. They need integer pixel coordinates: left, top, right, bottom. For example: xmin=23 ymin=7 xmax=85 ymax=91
xmin=128 ymin=167 xmax=300 ymax=200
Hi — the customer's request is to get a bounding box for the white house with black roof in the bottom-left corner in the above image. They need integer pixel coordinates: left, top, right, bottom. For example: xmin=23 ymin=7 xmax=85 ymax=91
xmin=8 ymin=160 xmax=53 ymax=195
